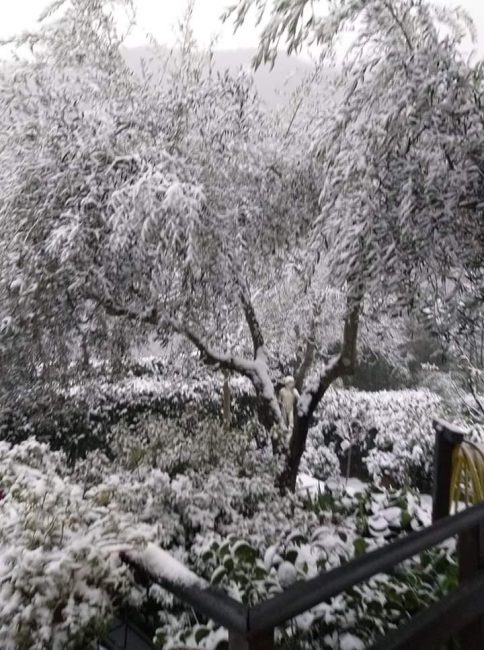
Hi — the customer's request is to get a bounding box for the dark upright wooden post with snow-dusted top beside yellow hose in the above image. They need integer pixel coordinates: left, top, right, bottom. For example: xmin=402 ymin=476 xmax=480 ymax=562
xmin=432 ymin=420 xmax=464 ymax=521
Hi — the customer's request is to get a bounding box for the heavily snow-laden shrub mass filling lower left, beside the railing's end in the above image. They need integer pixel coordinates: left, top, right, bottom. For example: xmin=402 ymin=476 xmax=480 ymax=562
xmin=0 ymin=428 xmax=280 ymax=650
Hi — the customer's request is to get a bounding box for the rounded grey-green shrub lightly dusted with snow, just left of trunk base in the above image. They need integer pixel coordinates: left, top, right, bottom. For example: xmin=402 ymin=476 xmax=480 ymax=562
xmin=72 ymin=413 xmax=292 ymax=548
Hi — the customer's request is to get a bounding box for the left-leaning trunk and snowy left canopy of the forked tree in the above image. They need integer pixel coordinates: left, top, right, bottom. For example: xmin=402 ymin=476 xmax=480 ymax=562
xmin=2 ymin=0 xmax=317 ymax=446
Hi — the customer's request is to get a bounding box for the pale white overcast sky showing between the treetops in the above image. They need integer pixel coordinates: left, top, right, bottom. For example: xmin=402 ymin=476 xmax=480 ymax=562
xmin=0 ymin=0 xmax=484 ymax=57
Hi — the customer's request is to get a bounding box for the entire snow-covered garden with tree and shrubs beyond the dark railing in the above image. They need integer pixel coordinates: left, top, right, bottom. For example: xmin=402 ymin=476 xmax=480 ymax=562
xmin=0 ymin=0 xmax=484 ymax=650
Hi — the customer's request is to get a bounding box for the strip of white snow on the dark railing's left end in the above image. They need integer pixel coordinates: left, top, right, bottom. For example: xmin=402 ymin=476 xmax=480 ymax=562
xmin=126 ymin=543 xmax=207 ymax=588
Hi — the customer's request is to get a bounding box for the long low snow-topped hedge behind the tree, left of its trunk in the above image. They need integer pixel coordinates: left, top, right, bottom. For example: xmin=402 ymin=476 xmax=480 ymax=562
xmin=0 ymin=374 xmax=253 ymax=462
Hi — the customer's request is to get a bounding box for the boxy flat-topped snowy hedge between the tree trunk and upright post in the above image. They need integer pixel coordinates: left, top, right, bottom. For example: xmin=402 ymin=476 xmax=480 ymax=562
xmin=304 ymin=389 xmax=444 ymax=489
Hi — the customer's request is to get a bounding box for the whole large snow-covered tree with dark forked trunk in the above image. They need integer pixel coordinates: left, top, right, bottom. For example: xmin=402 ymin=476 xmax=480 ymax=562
xmin=0 ymin=0 xmax=483 ymax=487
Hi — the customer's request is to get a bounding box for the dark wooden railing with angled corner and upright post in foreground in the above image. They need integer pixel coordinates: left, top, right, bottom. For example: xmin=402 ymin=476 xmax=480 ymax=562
xmin=120 ymin=421 xmax=484 ymax=650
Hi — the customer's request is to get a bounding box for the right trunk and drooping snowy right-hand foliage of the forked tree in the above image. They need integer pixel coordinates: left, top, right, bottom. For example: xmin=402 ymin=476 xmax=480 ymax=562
xmin=222 ymin=0 xmax=484 ymax=486
